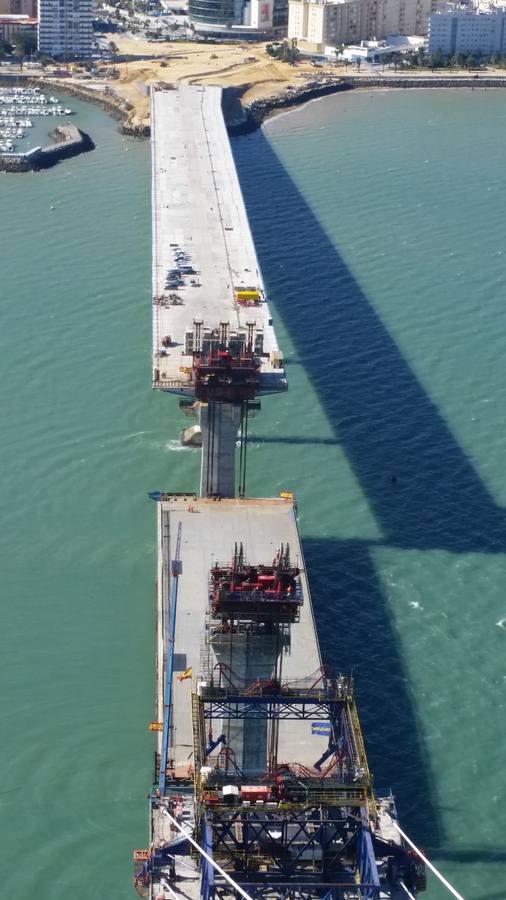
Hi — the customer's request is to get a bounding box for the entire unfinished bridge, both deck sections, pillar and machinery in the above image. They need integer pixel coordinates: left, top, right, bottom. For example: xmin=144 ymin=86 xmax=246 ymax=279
xmin=134 ymin=85 xmax=425 ymax=900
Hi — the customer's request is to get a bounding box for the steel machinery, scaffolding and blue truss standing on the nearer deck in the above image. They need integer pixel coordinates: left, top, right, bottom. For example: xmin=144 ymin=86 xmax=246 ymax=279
xmin=142 ymin=526 xmax=425 ymax=900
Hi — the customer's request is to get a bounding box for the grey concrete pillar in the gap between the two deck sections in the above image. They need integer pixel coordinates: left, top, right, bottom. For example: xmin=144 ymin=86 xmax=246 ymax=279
xmin=199 ymin=401 xmax=241 ymax=497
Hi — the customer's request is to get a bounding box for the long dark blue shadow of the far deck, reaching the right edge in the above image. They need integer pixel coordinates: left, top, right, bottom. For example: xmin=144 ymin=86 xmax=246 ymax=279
xmin=234 ymin=125 xmax=506 ymax=553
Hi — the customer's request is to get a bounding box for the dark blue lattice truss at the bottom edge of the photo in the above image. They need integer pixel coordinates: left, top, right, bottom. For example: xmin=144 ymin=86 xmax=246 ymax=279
xmin=201 ymin=807 xmax=382 ymax=900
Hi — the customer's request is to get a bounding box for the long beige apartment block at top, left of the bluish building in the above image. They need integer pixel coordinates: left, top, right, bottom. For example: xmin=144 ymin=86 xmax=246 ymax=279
xmin=288 ymin=0 xmax=435 ymax=53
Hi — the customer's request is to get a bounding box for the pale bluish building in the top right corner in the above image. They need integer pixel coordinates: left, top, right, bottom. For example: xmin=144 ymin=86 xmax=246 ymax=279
xmin=428 ymin=8 xmax=506 ymax=56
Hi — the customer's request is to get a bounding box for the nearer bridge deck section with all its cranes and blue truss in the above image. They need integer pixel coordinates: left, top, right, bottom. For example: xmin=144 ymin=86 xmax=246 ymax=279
xmin=138 ymin=494 xmax=425 ymax=900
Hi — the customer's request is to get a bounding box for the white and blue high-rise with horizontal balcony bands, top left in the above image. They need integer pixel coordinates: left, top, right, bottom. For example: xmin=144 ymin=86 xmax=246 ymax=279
xmin=38 ymin=0 xmax=93 ymax=59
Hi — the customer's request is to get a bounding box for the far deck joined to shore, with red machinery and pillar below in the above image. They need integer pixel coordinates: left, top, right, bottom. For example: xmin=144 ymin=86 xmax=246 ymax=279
xmin=151 ymin=85 xmax=287 ymax=497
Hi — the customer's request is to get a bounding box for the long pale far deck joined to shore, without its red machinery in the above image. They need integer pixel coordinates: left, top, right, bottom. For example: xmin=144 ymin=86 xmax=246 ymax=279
xmin=151 ymin=85 xmax=286 ymax=396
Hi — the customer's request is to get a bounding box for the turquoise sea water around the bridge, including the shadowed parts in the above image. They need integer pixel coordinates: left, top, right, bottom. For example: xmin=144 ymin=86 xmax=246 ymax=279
xmin=0 ymin=91 xmax=506 ymax=900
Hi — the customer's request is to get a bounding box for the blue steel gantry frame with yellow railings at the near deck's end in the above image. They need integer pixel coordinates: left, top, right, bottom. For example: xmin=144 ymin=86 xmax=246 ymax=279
xmin=190 ymin=666 xmax=422 ymax=900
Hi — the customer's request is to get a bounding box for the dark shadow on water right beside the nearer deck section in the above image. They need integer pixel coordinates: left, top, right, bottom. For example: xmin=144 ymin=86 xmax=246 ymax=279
xmin=303 ymin=538 xmax=442 ymax=846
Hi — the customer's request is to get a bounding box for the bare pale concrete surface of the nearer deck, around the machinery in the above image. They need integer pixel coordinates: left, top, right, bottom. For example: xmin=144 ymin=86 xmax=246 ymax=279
xmin=158 ymin=497 xmax=328 ymax=774
